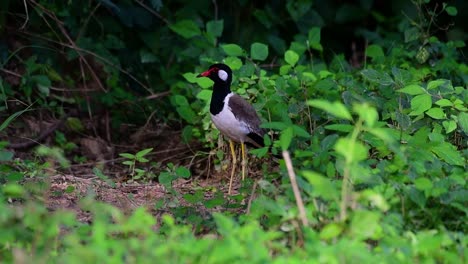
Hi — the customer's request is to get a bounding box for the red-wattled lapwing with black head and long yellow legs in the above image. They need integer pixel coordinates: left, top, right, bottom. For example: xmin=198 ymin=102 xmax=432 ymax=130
xmin=197 ymin=64 xmax=265 ymax=194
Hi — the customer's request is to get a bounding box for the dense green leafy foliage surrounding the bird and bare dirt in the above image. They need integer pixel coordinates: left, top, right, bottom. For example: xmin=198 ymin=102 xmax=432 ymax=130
xmin=0 ymin=1 xmax=468 ymax=263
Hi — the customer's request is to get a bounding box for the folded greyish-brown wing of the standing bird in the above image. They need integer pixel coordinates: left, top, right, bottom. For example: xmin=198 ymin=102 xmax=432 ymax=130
xmin=228 ymin=94 xmax=265 ymax=146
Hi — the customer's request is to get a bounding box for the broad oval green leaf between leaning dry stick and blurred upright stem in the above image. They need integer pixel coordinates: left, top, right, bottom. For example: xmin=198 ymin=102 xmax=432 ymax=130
xmin=301 ymin=171 xmax=339 ymax=200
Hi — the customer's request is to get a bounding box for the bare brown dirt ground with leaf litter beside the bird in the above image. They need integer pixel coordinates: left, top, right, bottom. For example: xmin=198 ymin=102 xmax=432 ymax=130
xmin=0 ymin=112 xmax=259 ymax=222
